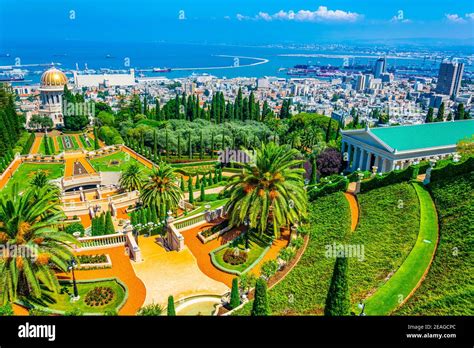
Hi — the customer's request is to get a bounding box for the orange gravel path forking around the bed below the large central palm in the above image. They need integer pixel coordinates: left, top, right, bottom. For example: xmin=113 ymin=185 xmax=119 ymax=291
xmin=181 ymin=223 xmax=241 ymax=287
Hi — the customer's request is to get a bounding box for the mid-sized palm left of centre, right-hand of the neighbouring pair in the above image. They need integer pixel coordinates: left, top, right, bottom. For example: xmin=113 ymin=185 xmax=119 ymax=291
xmin=140 ymin=162 xmax=183 ymax=216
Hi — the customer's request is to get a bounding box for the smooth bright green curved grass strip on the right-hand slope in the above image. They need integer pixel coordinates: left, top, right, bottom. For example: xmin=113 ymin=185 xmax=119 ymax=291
xmin=365 ymin=183 xmax=438 ymax=315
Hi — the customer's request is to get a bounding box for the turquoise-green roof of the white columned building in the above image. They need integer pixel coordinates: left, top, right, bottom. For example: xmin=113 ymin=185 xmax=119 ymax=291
xmin=370 ymin=120 xmax=474 ymax=151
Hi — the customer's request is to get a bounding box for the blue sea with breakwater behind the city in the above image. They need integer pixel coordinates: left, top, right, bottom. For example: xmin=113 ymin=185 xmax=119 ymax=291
xmin=0 ymin=41 xmax=471 ymax=83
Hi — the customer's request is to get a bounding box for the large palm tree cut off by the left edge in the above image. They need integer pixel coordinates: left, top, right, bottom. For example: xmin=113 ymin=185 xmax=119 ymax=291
xmin=0 ymin=184 xmax=77 ymax=304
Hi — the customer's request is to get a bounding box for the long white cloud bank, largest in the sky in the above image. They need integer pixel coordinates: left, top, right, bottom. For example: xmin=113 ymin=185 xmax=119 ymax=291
xmin=237 ymin=6 xmax=362 ymax=22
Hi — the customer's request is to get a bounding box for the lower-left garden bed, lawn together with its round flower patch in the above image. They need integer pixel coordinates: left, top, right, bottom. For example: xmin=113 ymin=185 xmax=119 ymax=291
xmin=18 ymin=278 xmax=128 ymax=315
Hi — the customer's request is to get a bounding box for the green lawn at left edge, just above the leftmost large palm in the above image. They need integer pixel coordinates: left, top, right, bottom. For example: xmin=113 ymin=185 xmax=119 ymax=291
xmin=2 ymin=163 xmax=64 ymax=192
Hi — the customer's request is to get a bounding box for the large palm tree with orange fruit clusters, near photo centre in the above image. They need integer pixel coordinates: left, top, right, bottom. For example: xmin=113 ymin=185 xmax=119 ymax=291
xmin=225 ymin=143 xmax=307 ymax=236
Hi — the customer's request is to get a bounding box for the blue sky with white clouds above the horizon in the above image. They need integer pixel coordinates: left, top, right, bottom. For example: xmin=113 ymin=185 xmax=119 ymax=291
xmin=0 ymin=0 xmax=474 ymax=45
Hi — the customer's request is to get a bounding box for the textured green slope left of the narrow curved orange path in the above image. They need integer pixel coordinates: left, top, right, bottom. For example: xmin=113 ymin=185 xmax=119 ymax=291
xmin=236 ymin=192 xmax=351 ymax=315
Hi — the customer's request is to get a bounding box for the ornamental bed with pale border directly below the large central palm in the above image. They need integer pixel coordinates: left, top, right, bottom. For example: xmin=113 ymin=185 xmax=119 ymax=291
xmin=210 ymin=233 xmax=272 ymax=276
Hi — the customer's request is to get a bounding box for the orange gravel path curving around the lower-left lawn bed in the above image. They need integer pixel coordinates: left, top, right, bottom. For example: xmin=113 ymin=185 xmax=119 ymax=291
xmin=58 ymin=246 xmax=146 ymax=315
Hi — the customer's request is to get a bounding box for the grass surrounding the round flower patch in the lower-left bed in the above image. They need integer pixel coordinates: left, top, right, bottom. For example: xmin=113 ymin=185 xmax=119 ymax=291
xmin=24 ymin=279 xmax=127 ymax=314
